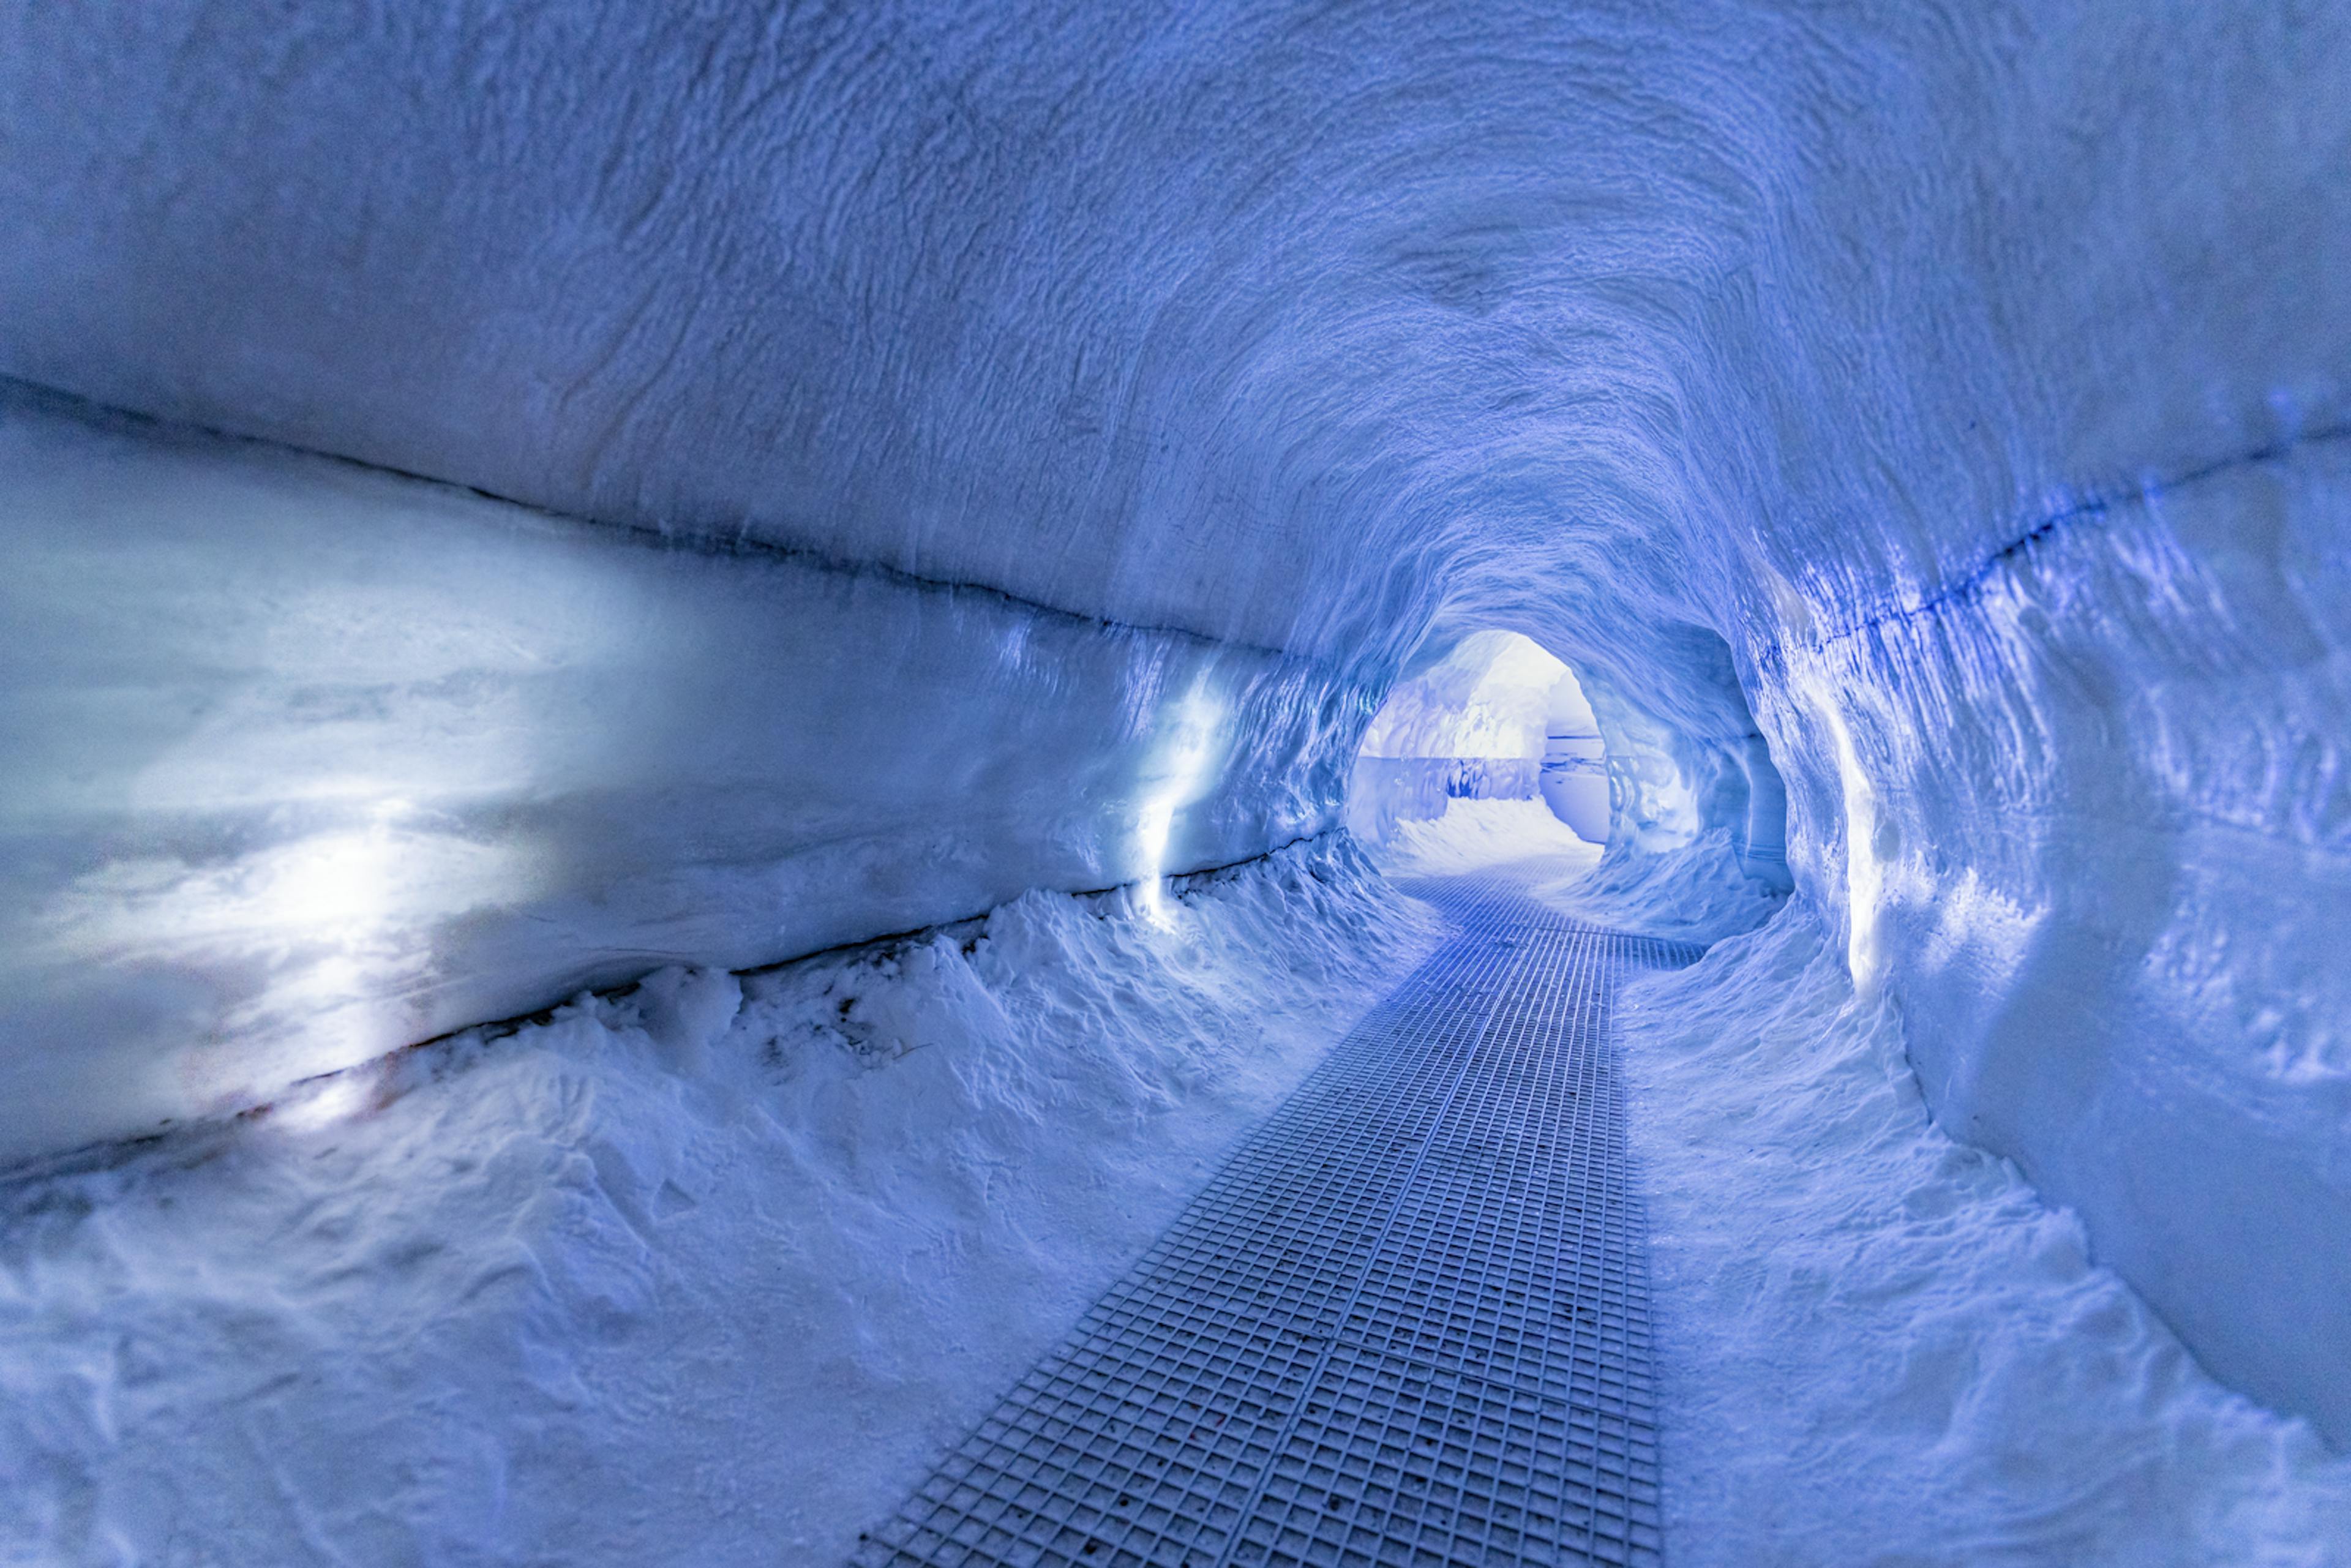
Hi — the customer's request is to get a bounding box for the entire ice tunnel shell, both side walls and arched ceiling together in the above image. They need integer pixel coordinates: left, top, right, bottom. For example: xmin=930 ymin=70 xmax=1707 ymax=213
xmin=0 ymin=0 xmax=2351 ymax=1441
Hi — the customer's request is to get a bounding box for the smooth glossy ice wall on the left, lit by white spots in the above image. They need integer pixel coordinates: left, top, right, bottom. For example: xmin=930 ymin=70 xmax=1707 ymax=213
xmin=0 ymin=395 xmax=1338 ymax=1161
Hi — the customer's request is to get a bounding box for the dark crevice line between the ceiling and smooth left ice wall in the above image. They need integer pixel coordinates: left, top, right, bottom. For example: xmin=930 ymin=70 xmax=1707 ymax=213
xmin=0 ymin=373 xmax=1335 ymax=675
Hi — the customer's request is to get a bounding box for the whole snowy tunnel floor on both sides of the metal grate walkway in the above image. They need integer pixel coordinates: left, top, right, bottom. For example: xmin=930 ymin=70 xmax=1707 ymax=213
xmin=0 ymin=801 xmax=2351 ymax=1568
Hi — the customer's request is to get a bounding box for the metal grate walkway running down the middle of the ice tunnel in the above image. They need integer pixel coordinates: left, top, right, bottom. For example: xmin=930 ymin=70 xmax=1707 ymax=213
xmin=856 ymin=870 xmax=1697 ymax=1568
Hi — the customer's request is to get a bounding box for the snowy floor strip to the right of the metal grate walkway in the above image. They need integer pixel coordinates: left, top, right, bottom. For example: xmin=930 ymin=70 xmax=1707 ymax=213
xmin=1618 ymin=902 xmax=2351 ymax=1568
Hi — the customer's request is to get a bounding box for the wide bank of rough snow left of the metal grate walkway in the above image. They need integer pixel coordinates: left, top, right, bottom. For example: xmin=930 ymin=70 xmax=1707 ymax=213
xmin=0 ymin=846 xmax=1434 ymax=1568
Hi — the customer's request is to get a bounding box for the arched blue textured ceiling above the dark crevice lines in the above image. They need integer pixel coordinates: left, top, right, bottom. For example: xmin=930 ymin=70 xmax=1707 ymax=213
xmin=0 ymin=0 xmax=2351 ymax=681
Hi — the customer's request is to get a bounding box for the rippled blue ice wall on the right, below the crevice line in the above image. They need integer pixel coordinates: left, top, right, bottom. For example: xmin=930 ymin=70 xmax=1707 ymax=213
xmin=1777 ymin=440 xmax=2351 ymax=1444
